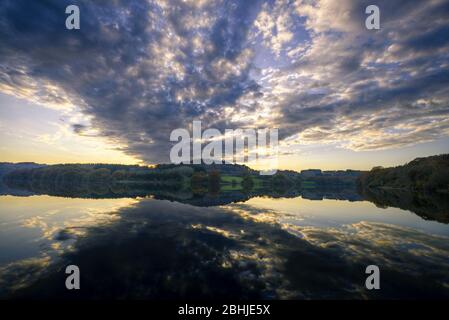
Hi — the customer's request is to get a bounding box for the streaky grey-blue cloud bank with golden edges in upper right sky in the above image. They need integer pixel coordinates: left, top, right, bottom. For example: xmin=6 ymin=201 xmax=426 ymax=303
xmin=273 ymin=0 xmax=449 ymax=150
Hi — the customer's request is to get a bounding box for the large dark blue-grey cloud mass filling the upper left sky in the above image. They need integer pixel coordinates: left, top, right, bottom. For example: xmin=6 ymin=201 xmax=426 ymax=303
xmin=0 ymin=1 xmax=264 ymax=161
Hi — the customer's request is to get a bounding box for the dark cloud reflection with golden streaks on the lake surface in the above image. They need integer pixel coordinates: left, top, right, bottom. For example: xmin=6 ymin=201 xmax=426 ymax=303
xmin=1 ymin=199 xmax=449 ymax=299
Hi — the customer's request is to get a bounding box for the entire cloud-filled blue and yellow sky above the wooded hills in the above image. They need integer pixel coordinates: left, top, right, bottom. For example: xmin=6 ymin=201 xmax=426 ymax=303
xmin=0 ymin=0 xmax=449 ymax=170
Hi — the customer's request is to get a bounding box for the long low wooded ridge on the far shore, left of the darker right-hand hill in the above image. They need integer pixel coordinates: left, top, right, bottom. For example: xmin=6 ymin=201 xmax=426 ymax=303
xmin=0 ymin=162 xmax=360 ymax=189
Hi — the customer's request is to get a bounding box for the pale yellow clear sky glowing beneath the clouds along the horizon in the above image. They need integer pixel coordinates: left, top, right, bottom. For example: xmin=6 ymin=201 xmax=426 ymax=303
xmin=0 ymin=94 xmax=449 ymax=171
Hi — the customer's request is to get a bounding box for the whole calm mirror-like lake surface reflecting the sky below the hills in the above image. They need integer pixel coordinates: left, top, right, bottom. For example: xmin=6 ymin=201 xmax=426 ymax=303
xmin=0 ymin=190 xmax=449 ymax=299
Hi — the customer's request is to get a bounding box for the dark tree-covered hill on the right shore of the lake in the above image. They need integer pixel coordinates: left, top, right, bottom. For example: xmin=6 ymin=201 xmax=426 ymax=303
xmin=357 ymin=154 xmax=449 ymax=193
